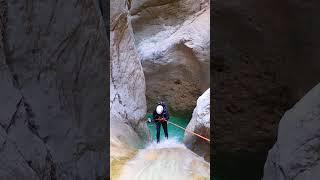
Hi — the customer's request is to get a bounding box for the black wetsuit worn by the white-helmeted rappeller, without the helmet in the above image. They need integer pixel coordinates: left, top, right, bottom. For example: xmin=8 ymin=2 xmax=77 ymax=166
xmin=153 ymin=105 xmax=169 ymax=143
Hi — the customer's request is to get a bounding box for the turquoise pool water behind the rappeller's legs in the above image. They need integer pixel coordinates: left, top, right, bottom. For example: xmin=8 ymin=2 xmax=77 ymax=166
xmin=147 ymin=114 xmax=190 ymax=142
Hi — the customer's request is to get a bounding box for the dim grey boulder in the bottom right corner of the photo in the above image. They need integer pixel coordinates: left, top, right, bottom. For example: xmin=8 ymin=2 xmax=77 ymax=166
xmin=263 ymin=84 xmax=320 ymax=180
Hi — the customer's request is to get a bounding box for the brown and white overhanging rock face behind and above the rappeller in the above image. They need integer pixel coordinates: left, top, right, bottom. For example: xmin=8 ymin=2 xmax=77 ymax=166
xmin=130 ymin=0 xmax=210 ymax=115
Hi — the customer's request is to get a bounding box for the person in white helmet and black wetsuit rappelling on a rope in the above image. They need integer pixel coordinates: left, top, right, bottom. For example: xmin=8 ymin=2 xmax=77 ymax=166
xmin=153 ymin=101 xmax=169 ymax=143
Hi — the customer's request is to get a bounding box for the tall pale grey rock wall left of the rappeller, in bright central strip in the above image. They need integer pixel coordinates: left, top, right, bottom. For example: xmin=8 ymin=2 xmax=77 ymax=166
xmin=110 ymin=0 xmax=146 ymax=148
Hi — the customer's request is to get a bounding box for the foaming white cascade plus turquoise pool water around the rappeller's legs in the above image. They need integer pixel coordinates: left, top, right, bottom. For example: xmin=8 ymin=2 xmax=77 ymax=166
xmin=113 ymin=115 xmax=210 ymax=180
